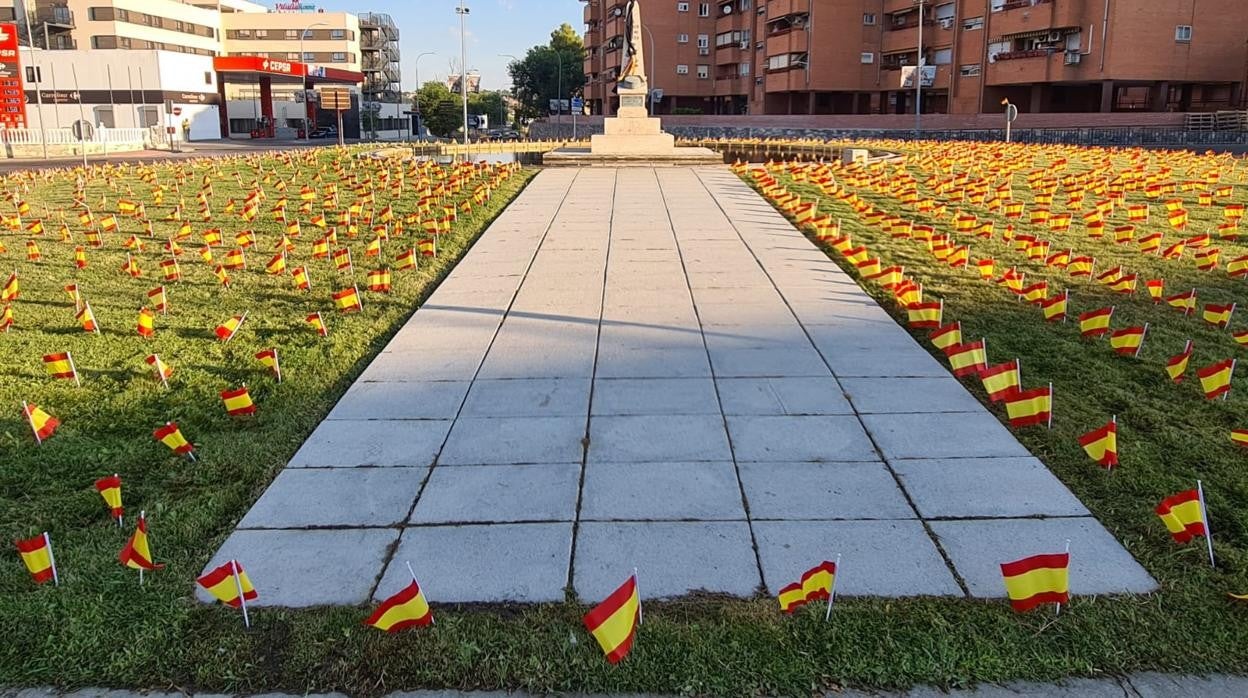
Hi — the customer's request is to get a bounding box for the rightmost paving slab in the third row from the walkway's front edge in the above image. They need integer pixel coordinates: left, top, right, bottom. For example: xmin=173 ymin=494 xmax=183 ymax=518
xmin=862 ymin=410 xmax=1043 ymax=462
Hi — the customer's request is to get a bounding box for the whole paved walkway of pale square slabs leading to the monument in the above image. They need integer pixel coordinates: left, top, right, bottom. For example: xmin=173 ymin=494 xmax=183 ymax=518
xmin=197 ymin=167 xmax=1156 ymax=606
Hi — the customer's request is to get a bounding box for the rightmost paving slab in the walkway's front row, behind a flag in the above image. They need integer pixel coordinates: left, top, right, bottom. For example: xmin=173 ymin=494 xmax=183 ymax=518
xmin=931 ymin=517 xmax=1157 ymax=598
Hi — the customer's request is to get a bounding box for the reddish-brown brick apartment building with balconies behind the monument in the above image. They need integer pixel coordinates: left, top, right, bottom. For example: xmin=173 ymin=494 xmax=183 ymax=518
xmin=584 ymin=0 xmax=1248 ymax=114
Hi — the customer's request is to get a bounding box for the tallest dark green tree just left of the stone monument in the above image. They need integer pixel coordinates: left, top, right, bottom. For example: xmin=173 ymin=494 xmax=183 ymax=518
xmin=508 ymin=24 xmax=585 ymax=119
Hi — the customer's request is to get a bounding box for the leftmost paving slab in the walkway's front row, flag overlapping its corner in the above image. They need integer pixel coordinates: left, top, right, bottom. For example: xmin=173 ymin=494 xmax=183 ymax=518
xmin=195 ymin=528 xmax=398 ymax=608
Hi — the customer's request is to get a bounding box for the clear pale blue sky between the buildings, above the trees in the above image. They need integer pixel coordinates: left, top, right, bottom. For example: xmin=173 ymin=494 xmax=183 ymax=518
xmin=309 ymin=0 xmax=585 ymax=90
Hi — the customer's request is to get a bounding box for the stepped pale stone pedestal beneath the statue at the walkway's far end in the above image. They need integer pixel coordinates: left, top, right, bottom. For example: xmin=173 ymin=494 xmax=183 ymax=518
xmin=542 ymin=81 xmax=724 ymax=166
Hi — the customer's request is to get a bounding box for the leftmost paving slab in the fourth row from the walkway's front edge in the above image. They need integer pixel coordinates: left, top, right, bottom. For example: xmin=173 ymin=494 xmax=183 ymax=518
xmin=326 ymin=381 xmax=470 ymax=420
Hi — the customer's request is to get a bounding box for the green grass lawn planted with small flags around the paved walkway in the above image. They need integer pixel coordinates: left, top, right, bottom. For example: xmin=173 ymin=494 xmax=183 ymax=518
xmin=7 ymin=140 xmax=1248 ymax=696
